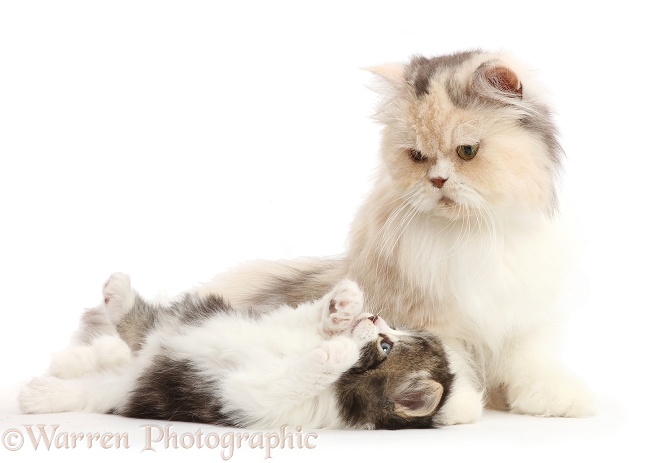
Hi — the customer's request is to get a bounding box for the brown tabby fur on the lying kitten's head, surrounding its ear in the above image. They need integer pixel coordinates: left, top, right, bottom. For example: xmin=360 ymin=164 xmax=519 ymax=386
xmin=335 ymin=332 xmax=454 ymax=429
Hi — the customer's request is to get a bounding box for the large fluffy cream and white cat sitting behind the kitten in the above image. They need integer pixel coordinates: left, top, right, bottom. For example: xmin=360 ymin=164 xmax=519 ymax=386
xmin=192 ymin=50 xmax=594 ymax=424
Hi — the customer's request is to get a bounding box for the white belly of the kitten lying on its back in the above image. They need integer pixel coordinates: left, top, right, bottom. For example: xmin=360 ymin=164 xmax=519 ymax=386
xmin=155 ymin=314 xmax=342 ymax=429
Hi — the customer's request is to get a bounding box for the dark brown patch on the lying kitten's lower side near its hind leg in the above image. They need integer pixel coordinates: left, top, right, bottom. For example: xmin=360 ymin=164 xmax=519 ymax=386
xmin=120 ymin=355 xmax=241 ymax=426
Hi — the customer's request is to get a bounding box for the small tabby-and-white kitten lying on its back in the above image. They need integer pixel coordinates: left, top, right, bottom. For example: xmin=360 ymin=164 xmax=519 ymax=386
xmin=19 ymin=274 xmax=453 ymax=429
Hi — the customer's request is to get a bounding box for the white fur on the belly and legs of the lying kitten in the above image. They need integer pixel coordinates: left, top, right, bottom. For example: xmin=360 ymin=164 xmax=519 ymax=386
xmin=19 ymin=281 xmax=384 ymax=428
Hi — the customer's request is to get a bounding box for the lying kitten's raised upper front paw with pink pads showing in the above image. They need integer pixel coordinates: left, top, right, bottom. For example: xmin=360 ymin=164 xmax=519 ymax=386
xmin=322 ymin=280 xmax=364 ymax=334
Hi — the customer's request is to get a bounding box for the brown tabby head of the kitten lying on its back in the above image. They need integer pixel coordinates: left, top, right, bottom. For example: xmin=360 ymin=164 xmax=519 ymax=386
xmin=336 ymin=317 xmax=454 ymax=429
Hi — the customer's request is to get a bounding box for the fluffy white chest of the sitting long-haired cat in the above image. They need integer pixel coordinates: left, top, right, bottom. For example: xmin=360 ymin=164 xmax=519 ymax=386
xmin=399 ymin=214 xmax=565 ymax=351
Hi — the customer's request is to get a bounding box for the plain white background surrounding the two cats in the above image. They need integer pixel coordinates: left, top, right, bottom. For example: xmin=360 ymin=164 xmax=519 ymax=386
xmin=0 ymin=0 xmax=663 ymax=461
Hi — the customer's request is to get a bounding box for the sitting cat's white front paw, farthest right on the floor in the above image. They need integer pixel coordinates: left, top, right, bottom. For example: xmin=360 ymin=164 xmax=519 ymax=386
xmin=507 ymin=378 xmax=596 ymax=418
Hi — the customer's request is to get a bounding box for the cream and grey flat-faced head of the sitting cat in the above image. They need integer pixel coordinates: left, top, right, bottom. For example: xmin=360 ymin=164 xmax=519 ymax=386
xmin=372 ymin=51 xmax=562 ymax=219
